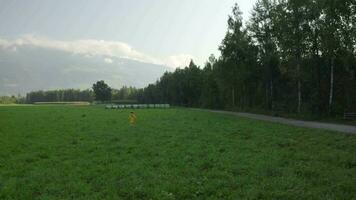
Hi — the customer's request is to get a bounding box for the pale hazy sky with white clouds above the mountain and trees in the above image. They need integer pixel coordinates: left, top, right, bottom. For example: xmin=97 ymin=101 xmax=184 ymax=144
xmin=0 ymin=0 xmax=255 ymax=68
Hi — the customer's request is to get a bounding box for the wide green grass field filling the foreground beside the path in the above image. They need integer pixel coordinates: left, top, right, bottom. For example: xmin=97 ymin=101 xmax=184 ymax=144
xmin=0 ymin=106 xmax=356 ymax=200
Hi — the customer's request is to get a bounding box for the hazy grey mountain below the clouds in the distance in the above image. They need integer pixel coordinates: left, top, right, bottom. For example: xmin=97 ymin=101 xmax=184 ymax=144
xmin=0 ymin=45 xmax=170 ymax=95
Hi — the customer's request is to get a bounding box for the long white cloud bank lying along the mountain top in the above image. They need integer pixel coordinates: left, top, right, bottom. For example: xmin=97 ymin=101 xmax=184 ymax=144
xmin=0 ymin=35 xmax=193 ymax=68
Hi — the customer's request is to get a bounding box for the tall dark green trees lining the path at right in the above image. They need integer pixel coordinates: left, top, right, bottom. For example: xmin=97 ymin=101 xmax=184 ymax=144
xmin=137 ymin=0 xmax=356 ymax=116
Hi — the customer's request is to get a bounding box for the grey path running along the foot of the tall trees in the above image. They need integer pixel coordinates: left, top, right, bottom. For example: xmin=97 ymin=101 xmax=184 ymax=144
xmin=198 ymin=109 xmax=356 ymax=134
